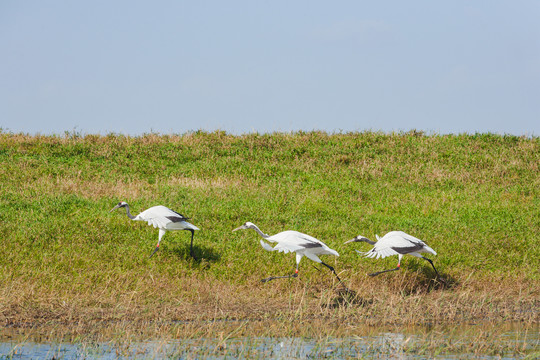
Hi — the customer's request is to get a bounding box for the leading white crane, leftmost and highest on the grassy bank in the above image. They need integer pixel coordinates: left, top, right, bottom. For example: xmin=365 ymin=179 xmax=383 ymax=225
xmin=110 ymin=201 xmax=199 ymax=259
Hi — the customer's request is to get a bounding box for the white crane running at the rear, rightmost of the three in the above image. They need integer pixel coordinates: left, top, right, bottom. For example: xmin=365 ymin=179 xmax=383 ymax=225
xmin=345 ymin=231 xmax=441 ymax=279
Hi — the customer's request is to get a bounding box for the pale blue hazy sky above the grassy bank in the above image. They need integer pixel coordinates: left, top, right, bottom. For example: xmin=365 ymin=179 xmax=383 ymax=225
xmin=0 ymin=0 xmax=540 ymax=136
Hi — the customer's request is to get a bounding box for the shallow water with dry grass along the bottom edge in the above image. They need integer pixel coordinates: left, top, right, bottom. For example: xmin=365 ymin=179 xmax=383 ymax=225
xmin=0 ymin=324 xmax=540 ymax=359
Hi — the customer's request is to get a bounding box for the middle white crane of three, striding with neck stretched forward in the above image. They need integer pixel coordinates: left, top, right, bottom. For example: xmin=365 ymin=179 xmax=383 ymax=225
xmin=233 ymin=221 xmax=341 ymax=282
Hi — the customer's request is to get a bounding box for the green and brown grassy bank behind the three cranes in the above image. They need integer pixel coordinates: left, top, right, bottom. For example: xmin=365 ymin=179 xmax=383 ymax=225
xmin=0 ymin=132 xmax=540 ymax=324
